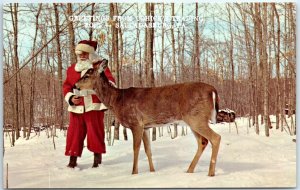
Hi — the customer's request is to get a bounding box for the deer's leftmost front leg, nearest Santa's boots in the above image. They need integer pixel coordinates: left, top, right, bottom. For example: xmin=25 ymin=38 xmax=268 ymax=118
xmin=132 ymin=126 xmax=143 ymax=174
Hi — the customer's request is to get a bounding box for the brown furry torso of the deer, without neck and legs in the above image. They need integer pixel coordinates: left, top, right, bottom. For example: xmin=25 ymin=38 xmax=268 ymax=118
xmin=116 ymin=82 xmax=215 ymax=125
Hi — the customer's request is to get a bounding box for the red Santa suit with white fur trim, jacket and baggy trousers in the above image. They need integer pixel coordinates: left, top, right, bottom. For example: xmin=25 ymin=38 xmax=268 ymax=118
xmin=63 ymin=63 xmax=115 ymax=157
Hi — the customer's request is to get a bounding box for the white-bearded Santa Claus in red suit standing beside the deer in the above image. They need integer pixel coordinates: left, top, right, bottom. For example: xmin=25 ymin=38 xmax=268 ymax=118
xmin=63 ymin=40 xmax=115 ymax=168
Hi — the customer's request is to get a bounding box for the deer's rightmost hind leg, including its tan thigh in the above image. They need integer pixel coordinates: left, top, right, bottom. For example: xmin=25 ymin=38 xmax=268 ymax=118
xmin=186 ymin=117 xmax=221 ymax=176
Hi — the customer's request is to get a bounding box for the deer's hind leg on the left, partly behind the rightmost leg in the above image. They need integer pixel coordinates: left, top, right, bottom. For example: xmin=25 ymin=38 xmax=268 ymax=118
xmin=187 ymin=130 xmax=208 ymax=173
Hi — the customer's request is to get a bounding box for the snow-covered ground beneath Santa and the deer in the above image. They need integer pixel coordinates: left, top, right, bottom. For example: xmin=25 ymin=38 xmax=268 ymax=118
xmin=3 ymin=116 xmax=296 ymax=188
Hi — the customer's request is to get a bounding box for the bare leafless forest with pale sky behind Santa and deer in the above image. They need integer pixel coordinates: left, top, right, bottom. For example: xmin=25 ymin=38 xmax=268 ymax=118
xmin=3 ymin=2 xmax=296 ymax=144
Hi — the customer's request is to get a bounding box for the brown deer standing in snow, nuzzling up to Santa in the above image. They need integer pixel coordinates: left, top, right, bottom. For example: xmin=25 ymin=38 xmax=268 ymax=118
xmin=75 ymin=59 xmax=221 ymax=176
